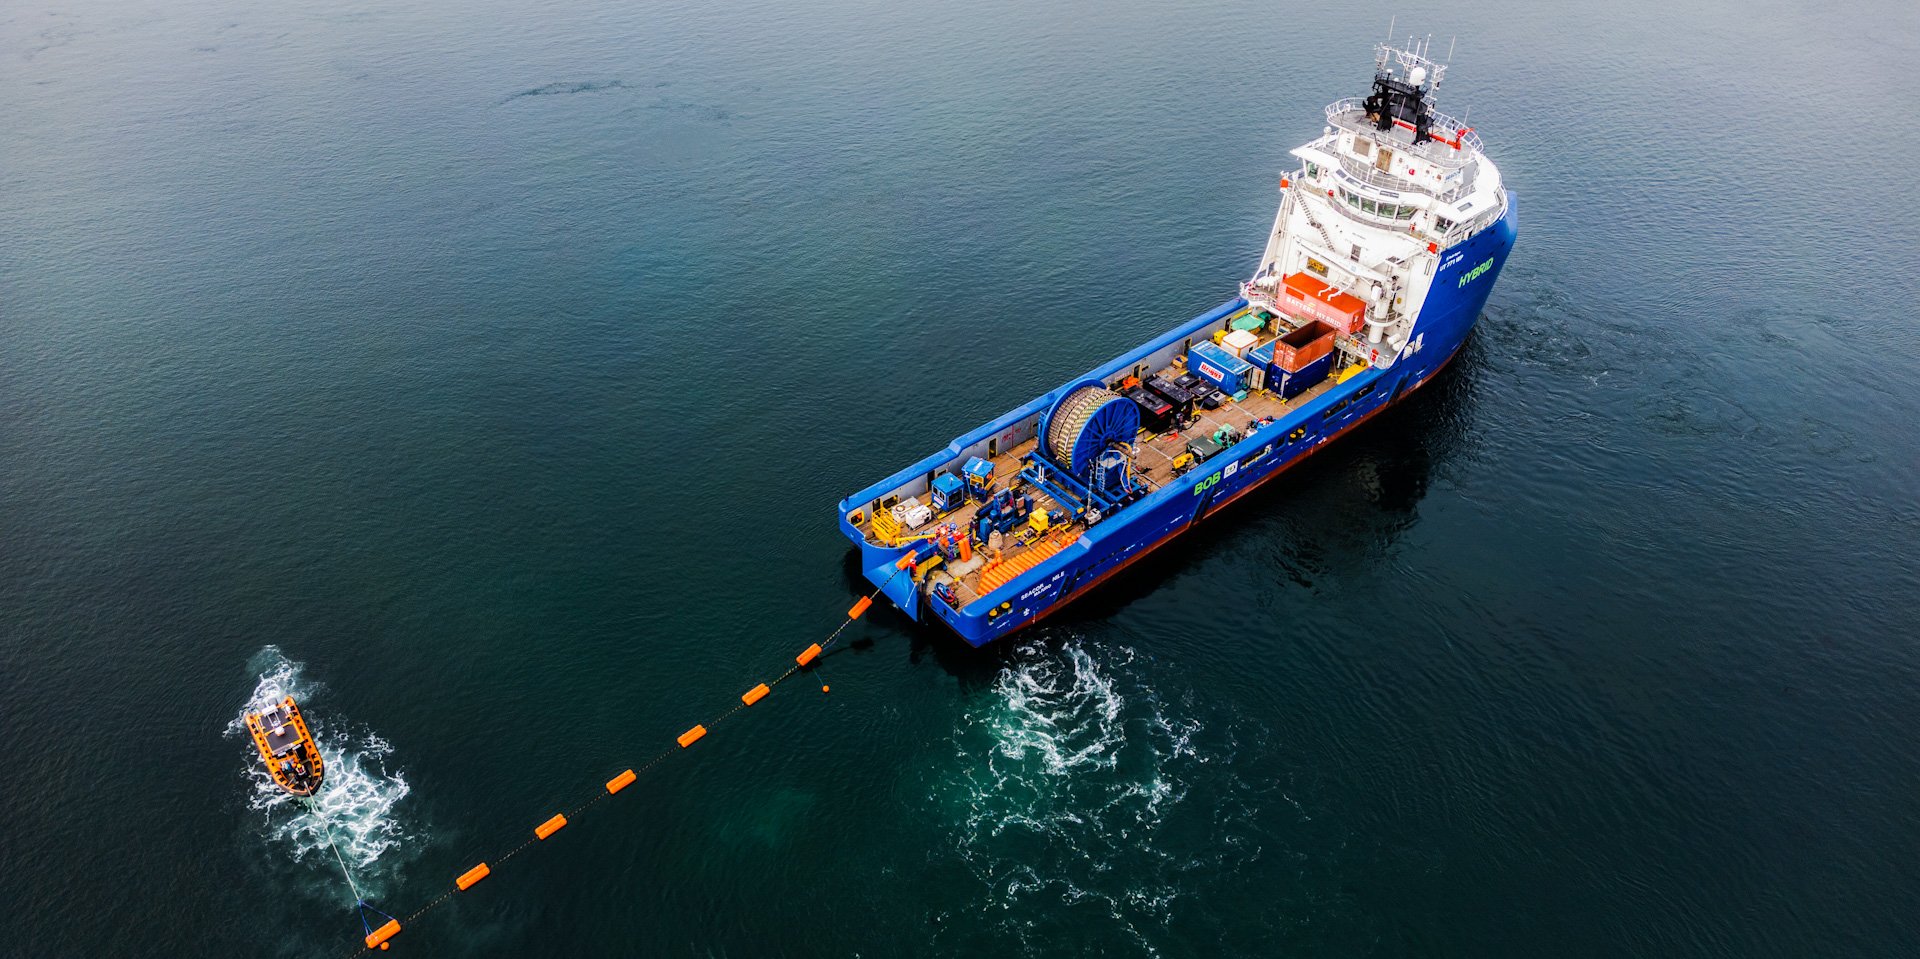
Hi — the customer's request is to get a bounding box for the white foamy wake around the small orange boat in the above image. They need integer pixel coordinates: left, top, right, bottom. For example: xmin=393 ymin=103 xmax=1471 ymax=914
xmin=227 ymin=646 xmax=411 ymax=894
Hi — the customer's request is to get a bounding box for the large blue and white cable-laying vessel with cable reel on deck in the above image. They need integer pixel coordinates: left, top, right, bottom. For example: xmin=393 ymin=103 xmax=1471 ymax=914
xmin=839 ymin=42 xmax=1515 ymax=646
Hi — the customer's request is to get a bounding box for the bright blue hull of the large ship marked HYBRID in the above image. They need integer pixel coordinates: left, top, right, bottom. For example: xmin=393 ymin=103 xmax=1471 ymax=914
xmin=839 ymin=194 xmax=1517 ymax=646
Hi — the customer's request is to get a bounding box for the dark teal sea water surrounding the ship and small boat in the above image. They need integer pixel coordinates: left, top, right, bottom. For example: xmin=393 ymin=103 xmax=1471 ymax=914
xmin=0 ymin=0 xmax=1920 ymax=957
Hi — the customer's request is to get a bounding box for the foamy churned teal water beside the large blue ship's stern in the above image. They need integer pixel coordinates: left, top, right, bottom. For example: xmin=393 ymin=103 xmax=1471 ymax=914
xmin=933 ymin=638 xmax=1260 ymax=953
